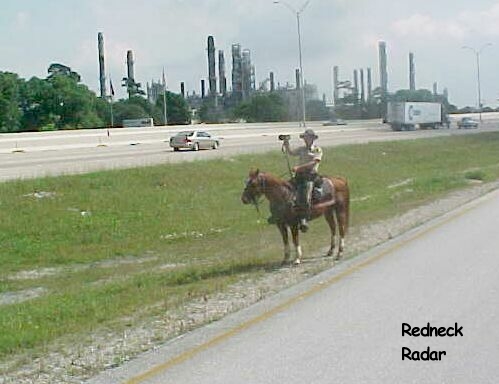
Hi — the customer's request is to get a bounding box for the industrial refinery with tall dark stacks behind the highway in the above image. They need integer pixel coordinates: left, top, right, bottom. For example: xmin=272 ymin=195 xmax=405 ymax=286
xmin=97 ymin=32 xmax=447 ymax=121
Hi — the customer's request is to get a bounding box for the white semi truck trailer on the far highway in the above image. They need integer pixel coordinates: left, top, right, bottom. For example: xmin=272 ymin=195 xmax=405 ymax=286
xmin=386 ymin=101 xmax=445 ymax=131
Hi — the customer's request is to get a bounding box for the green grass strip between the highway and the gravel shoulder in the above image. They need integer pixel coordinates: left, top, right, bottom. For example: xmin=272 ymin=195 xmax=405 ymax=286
xmin=0 ymin=133 xmax=499 ymax=358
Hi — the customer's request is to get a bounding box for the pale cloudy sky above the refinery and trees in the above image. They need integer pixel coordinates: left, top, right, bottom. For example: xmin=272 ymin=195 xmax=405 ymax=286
xmin=0 ymin=0 xmax=499 ymax=107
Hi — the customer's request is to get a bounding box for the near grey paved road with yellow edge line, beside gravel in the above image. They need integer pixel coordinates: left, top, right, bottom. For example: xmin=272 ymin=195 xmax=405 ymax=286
xmin=90 ymin=191 xmax=499 ymax=384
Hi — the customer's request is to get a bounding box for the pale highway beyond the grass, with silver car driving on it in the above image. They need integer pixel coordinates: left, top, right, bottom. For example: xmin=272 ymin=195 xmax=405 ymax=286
xmin=0 ymin=120 xmax=499 ymax=181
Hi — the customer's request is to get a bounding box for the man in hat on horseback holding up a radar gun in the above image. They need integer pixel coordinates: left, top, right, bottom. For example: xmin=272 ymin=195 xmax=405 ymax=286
xmin=282 ymin=129 xmax=322 ymax=232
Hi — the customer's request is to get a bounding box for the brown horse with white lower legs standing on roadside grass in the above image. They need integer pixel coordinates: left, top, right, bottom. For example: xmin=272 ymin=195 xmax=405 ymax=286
xmin=241 ymin=169 xmax=350 ymax=265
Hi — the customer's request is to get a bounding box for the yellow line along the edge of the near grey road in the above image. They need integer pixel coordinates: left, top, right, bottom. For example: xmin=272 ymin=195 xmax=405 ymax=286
xmin=125 ymin=191 xmax=494 ymax=384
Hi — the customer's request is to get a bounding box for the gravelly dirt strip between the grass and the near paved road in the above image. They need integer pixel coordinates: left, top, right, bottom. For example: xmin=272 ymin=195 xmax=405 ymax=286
xmin=0 ymin=182 xmax=499 ymax=384
